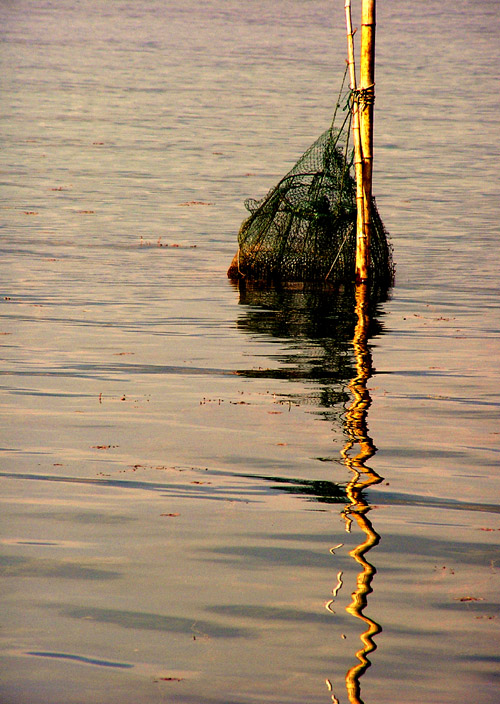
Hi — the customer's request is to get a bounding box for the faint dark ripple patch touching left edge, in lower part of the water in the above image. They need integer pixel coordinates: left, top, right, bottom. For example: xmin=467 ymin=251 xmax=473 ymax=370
xmin=0 ymin=555 xmax=121 ymax=581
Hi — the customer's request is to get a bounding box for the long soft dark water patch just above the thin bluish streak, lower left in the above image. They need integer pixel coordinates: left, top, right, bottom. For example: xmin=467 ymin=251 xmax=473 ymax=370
xmin=52 ymin=605 xmax=254 ymax=638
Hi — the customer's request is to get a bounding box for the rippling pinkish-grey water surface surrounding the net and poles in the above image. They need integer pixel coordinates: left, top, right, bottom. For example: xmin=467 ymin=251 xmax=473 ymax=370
xmin=0 ymin=0 xmax=500 ymax=704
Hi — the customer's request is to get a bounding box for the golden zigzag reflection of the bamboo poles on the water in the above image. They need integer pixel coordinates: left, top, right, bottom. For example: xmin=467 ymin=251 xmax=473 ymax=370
xmin=327 ymin=284 xmax=382 ymax=704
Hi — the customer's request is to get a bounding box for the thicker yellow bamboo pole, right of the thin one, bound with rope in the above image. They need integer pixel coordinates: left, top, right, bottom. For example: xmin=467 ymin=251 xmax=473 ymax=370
xmin=356 ymin=0 xmax=376 ymax=282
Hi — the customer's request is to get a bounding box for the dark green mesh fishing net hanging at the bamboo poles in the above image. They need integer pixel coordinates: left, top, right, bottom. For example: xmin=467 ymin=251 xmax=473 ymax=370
xmin=228 ymin=127 xmax=393 ymax=282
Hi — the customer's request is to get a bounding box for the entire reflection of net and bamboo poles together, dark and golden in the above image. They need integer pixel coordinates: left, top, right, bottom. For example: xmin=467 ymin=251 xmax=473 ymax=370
xmin=233 ymin=282 xmax=384 ymax=704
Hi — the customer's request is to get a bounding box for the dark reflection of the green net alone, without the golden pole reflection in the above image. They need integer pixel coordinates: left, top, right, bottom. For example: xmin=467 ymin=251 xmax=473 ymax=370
xmin=233 ymin=280 xmax=382 ymax=421
